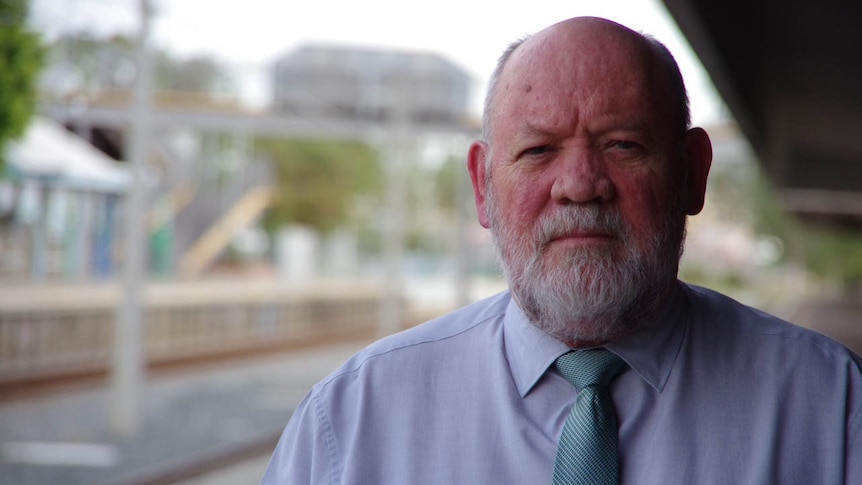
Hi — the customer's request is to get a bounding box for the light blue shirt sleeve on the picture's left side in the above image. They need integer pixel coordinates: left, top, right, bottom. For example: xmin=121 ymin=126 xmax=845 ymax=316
xmin=260 ymin=391 xmax=338 ymax=485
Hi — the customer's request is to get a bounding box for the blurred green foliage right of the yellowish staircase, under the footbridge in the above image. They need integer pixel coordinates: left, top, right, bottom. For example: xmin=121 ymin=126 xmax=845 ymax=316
xmin=256 ymin=139 xmax=383 ymax=232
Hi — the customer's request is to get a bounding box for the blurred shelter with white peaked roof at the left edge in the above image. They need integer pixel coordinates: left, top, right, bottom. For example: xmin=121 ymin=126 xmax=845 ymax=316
xmin=0 ymin=117 xmax=131 ymax=280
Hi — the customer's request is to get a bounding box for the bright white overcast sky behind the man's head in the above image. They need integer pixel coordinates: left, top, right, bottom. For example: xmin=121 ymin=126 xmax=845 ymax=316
xmin=31 ymin=0 xmax=721 ymax=123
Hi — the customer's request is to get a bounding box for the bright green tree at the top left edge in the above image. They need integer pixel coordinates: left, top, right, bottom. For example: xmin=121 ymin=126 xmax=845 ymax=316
xmin=0 ymin=0 xmax=44 ymax=171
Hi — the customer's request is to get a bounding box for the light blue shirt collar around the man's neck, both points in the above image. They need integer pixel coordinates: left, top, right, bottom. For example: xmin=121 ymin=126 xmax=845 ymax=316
xmin=503 ymin=284 xmax=688 ymax=397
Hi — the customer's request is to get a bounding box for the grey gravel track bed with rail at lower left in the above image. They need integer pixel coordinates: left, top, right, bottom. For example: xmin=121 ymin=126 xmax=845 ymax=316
xmin=0 ymin=341 xmax=368 ymax=485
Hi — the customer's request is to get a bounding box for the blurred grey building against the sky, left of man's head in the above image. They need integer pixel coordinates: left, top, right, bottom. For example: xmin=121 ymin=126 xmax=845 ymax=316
xmin=272 ymin=45 xmax=472 ymax=124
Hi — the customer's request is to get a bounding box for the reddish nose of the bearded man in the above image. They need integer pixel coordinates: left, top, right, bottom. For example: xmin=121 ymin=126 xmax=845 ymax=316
xmin=551 ymin=148 xmax=616 ymax=204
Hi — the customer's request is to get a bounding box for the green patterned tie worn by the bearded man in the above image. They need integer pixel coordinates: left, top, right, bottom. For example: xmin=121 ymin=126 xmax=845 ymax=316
xmin=553 ymin=349 xmax=626 ymax=485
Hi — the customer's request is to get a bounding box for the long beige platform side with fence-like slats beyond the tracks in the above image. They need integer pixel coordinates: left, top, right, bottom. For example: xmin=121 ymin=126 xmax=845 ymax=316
xmin=0 ymin=281 xmax=383 ymax=386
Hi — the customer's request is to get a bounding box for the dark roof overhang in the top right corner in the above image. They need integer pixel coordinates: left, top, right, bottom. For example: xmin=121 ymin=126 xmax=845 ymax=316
xmin=663 ymin=0 xmax=862 ymax=225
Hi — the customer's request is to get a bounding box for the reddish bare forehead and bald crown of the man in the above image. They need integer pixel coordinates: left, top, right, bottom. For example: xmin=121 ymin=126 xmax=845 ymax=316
xmin=494 ymin=24 xmax=665 ymax=136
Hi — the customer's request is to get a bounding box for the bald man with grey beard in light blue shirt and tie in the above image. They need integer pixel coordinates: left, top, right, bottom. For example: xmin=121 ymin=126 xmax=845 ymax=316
xmin=263 ymin=18 xmax=862 ymax=485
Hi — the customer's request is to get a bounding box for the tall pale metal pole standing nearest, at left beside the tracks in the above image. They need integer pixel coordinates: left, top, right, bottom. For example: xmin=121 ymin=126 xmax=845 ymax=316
xmin=111 ymin=0 xmax=152 ymax=436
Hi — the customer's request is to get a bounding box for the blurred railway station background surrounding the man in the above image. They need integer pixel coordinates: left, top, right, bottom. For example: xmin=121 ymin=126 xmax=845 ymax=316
xmin=0 ymin=0 xmax=862 ymax=485
